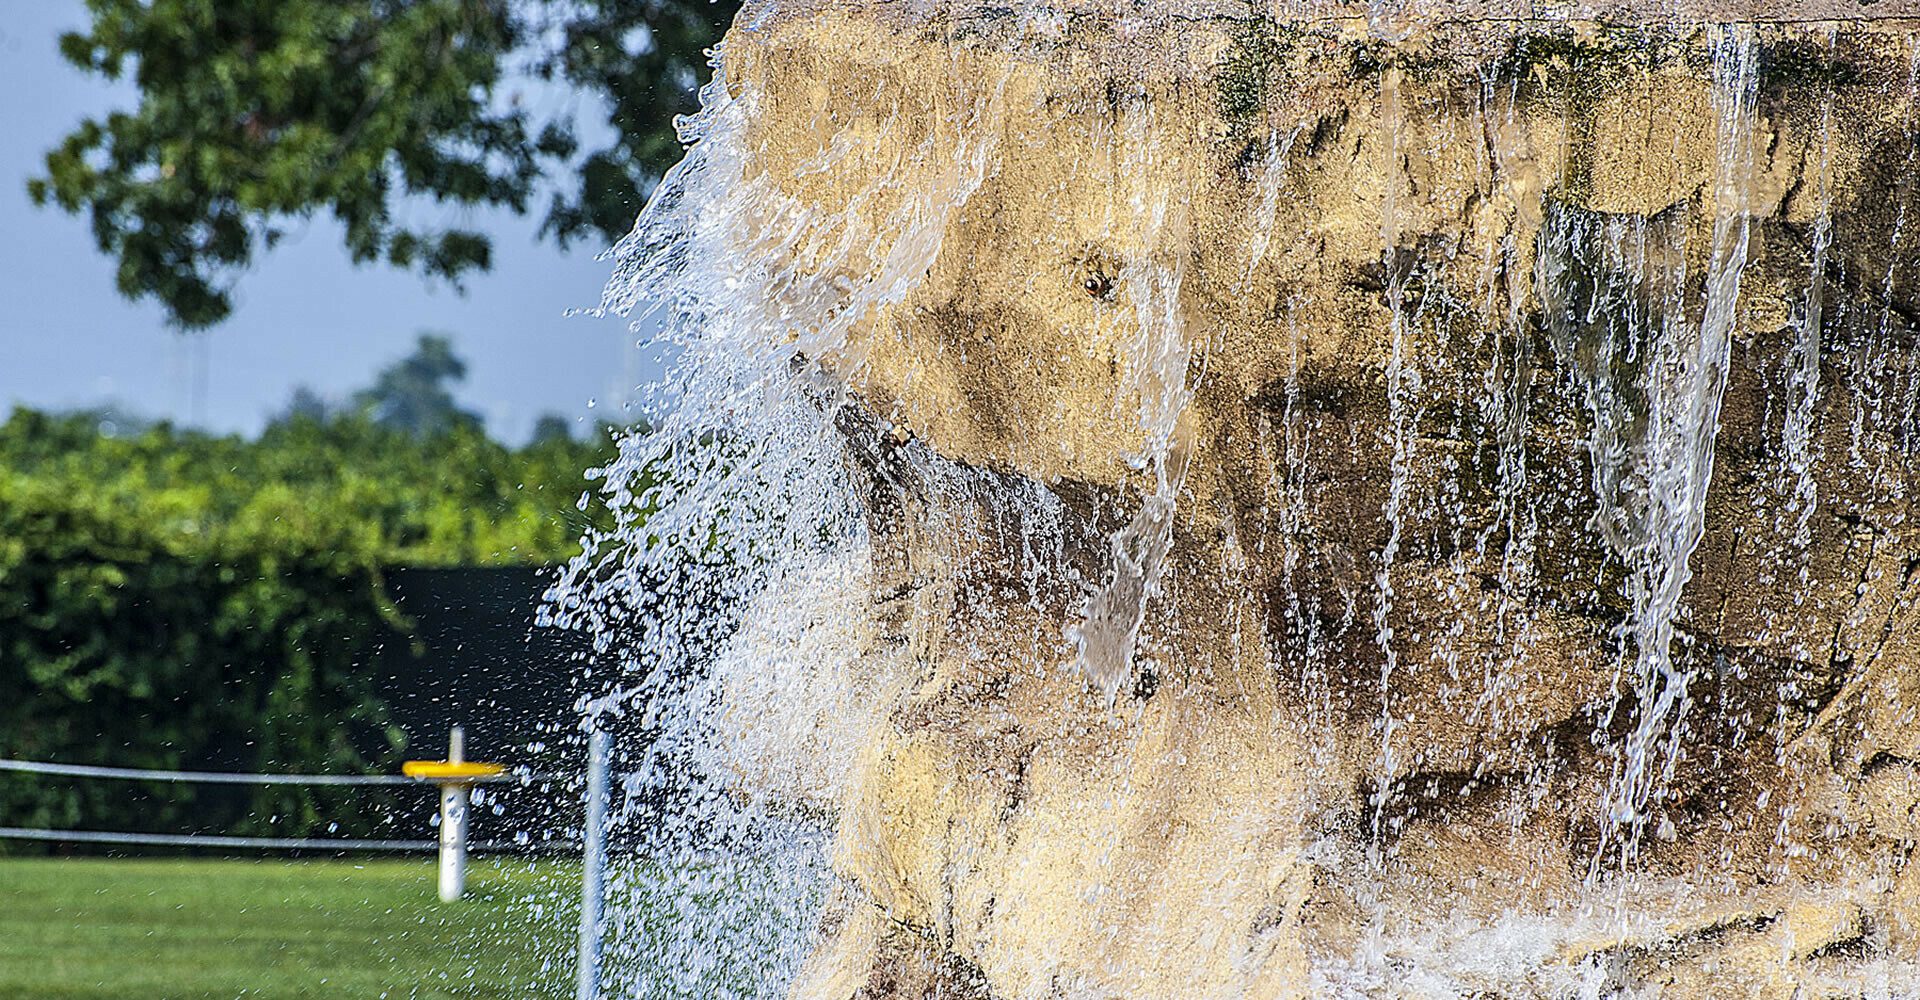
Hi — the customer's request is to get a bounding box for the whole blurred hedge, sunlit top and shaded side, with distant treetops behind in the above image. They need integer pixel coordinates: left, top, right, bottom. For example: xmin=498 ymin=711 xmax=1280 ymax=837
xmin=0 ymin=338 xmax=645 ymax=850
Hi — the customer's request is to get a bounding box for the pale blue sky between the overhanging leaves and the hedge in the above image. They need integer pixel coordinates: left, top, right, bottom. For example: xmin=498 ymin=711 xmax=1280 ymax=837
xmin=0 ymin=0 xmax=660 ymax=441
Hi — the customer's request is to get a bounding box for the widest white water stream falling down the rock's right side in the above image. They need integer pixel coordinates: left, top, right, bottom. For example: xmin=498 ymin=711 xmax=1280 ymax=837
xmin=1538 ymin=29 xmax=1755 ymax=845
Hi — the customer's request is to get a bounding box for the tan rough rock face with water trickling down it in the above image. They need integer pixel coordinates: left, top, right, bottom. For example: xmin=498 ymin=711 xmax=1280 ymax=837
xmin=708 ymin=0 xmax=1920 ymax=1000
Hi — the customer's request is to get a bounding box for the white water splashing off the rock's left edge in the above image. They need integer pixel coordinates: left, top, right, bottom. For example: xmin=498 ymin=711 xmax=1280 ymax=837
xmin=543 ymin=35 xmax=993 ymax=996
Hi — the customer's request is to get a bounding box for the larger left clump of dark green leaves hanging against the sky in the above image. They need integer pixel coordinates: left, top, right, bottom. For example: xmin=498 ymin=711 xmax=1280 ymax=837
xmin=29 ymin=0 xmax=538 ymax=326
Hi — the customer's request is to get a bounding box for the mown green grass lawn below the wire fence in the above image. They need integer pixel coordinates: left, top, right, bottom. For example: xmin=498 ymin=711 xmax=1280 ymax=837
xmin=0 ymin=858 xmax=578 ymax=1000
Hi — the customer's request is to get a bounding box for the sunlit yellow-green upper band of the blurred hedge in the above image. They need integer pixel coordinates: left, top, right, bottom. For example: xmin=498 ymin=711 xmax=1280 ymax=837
xmin=0 ymin=401 xmax=612 ymax=566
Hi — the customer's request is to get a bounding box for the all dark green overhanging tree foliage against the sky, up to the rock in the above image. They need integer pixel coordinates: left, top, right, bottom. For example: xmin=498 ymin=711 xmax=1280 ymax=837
xmin=39 ymin=0 xmax=739 ymax=328
